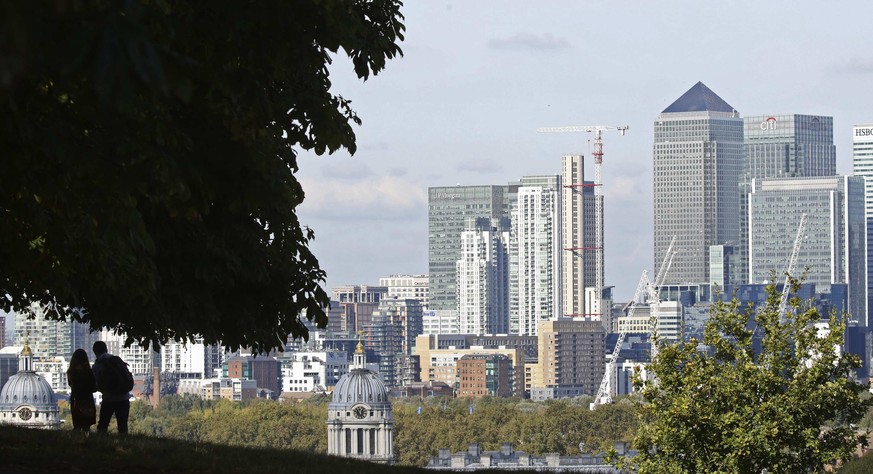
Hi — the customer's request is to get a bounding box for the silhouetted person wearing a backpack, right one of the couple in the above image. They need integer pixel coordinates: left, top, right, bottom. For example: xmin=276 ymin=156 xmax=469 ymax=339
xmin=91 ymin=341 xmax=133 ymax=435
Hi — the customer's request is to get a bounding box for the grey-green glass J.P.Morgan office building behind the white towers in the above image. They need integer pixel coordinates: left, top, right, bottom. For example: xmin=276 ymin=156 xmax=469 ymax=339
xmin=428 ymin=184 xmax=518 ymax=311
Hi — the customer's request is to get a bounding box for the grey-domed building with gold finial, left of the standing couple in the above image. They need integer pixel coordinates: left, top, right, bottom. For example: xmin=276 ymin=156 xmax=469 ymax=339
xmin=0 ymin=340 xmax=61 ymax=429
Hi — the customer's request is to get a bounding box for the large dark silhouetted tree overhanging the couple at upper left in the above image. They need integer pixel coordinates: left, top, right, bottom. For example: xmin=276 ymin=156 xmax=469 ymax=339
xmin=0 ymin=0 xmax=405 ymax=350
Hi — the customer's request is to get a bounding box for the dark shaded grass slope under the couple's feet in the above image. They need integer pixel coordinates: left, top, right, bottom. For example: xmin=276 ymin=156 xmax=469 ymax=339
xmin=0 ymin=426 xmax=432 ymax=474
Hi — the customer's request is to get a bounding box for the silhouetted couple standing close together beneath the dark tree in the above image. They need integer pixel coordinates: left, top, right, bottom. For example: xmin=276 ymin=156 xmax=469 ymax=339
xmin=67 ymin=341 xmax=133 ymax=434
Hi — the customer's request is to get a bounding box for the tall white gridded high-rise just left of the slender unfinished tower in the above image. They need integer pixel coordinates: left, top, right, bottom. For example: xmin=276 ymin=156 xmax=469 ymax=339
xmin=509 ymin=175 xmax=563 ymax=335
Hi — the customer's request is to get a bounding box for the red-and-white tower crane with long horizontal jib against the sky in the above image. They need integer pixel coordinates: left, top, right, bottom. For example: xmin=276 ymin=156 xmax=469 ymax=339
xmin=537 ymin=125 xmax=629 ymax=315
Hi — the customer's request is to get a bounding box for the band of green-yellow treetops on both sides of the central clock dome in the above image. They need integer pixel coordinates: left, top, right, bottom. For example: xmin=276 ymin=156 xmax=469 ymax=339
xmin=122 ymin=395 xmax=637 ymax=466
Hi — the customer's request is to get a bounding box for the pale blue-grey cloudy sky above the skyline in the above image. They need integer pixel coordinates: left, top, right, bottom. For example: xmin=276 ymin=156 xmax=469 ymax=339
xmin=298 ymin=0 xmax=873 ymax=301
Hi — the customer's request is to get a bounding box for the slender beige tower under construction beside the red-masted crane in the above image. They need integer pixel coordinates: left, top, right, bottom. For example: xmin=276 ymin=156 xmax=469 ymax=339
xmin=560 ymin=155 xmax=603 ymax=317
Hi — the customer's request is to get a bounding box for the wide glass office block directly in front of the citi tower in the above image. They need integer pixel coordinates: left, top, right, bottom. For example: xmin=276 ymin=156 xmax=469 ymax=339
xmin=749 ymin=176 xmax=868 ymax=326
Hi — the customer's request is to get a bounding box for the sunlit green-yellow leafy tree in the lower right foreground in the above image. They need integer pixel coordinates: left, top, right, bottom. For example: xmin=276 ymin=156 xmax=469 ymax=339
xmin=626 ymin=281 xmax=870 ymax=473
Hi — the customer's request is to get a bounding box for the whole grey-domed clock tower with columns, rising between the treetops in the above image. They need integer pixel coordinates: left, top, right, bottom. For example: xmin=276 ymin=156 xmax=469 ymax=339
xmin=327 ymin=341 xmax=394 ymax=464
